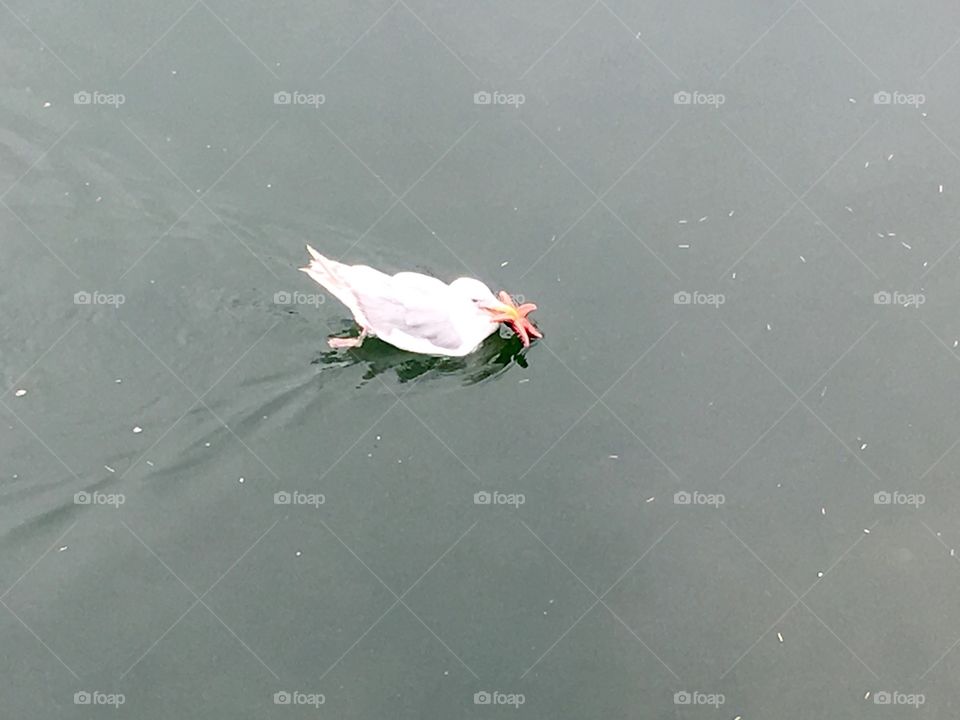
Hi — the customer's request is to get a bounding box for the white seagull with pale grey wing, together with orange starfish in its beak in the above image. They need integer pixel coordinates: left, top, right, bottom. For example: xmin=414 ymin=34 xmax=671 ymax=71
xmin=300 ymin=245 xmax=543 ymax=357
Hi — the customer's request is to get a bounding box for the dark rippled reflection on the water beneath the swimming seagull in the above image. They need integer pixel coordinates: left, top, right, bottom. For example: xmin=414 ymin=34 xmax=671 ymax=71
xmin=312 ymin=322 xmax=527 ymax=387
